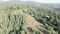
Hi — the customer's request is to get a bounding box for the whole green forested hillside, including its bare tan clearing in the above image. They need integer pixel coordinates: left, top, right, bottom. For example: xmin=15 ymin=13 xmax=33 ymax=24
xmin=0 ymin=4 xmax=60 ymax=34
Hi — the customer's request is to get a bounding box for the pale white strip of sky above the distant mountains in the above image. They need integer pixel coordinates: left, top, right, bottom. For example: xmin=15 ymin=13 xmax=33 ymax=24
xmin=0 ymin=0 xmax=60 ymax=3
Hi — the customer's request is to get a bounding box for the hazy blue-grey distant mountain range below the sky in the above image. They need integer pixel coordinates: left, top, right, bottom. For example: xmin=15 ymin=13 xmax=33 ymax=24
xmin=0 ymin=0 xmax=60 ymax=11
